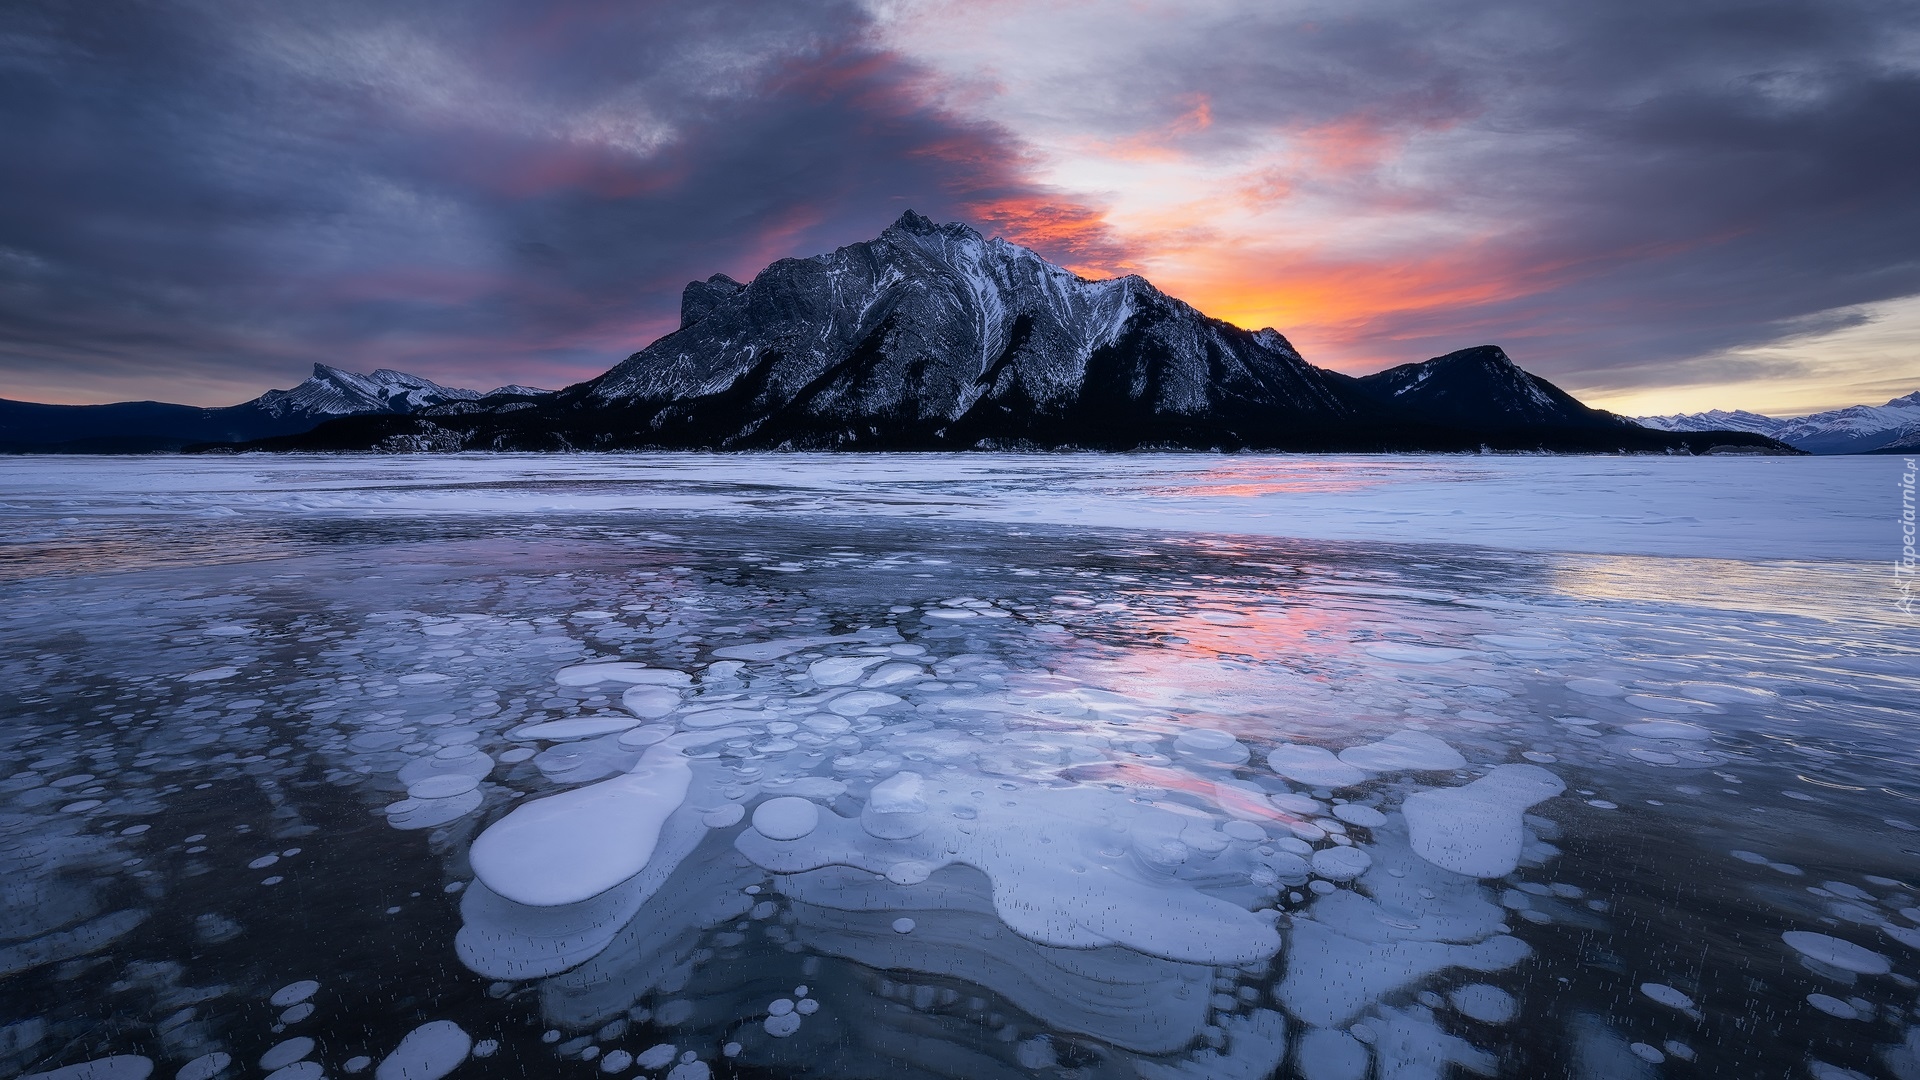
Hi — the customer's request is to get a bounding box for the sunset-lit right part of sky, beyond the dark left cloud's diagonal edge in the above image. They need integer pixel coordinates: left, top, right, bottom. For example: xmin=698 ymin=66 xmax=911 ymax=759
xmin=885 ymin=0 xmax=1920 ymax=407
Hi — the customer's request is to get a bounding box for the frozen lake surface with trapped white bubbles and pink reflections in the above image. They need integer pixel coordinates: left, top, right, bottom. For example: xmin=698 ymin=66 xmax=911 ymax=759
xmin=0 ymin=455 xmax=1920 ymax=1080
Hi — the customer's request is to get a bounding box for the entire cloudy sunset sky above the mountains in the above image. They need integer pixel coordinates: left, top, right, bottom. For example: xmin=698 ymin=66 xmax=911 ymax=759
xmin=0 ymin=0 xmax=1920 ymax=415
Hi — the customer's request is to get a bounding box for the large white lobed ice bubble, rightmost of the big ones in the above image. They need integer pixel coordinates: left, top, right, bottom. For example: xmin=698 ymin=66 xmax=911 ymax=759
xmin=1402 ymin=765 xmax=1567 ymax=878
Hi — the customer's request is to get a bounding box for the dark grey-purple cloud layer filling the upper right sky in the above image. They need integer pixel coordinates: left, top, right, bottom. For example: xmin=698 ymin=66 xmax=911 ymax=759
xmin=1052 ymin=0 xmax=1920 ymax=386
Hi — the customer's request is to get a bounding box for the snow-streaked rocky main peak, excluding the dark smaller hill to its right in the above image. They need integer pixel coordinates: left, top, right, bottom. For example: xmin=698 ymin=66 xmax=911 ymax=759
xmin=574 ymin=211 xmax=1357 ymax=448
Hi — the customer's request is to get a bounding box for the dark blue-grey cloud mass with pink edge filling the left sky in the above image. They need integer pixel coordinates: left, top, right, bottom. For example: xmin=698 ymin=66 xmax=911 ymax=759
xmin=0 ymin=0 xmax=1100 ymax=402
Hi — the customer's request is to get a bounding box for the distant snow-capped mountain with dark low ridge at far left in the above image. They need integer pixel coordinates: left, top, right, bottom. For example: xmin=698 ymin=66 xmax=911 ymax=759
xmin=0 ymin=363 xmax=543 ymax=454
